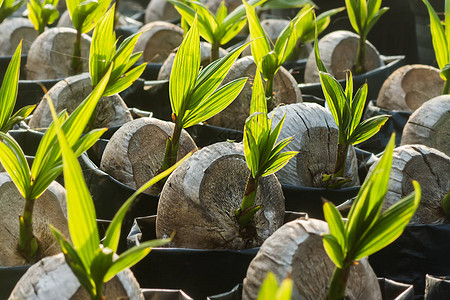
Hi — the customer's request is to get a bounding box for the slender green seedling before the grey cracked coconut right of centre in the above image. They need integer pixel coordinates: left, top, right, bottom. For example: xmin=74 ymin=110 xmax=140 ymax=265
xmin=314 ymin=36 xmax=389 ymax=187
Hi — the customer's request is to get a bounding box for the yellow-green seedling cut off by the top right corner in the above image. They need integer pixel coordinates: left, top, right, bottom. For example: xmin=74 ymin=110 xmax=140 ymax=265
xmin=422 ymin=0 xmax=450 ymax=94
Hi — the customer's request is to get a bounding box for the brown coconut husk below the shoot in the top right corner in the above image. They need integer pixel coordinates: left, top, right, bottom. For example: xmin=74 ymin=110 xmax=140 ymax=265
xmin=377 ymin=65 xmax=444 ymax=112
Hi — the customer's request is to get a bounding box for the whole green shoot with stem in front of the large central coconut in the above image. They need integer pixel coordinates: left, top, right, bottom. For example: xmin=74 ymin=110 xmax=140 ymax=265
xmin=235 ymin=70 xmax=298 ymax=228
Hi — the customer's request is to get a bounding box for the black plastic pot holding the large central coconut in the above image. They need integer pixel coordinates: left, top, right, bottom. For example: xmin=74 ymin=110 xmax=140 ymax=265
xmin=128 ymin=213 xmax=304 ymax=299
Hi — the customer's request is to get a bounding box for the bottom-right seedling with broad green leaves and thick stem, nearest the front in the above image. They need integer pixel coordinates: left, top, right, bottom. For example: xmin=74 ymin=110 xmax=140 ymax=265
xmin=323 ymin=136 xmax=421 ymax=300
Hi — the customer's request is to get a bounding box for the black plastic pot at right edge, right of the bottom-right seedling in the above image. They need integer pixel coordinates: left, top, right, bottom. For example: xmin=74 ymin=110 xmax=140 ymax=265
xmin=369 ymin=225 xmax=450 ymax=295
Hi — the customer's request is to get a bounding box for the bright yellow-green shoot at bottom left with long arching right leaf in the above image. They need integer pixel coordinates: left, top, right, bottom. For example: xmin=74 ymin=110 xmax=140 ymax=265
xmin=49 ymin=92 xmax=189 ymax=300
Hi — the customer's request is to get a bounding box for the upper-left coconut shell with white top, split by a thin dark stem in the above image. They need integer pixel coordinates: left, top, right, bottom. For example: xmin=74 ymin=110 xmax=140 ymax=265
xmin=26 ymin=27 xmax=91 ymax=80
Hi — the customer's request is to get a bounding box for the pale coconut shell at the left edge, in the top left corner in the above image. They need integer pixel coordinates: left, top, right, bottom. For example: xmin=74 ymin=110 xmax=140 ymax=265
xmin=0 ymin=18 xmax=38 ymax=56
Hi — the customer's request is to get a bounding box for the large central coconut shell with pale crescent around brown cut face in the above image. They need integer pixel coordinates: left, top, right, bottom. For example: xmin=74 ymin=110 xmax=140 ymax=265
xmin=156 ymin=142 xmax=284 ymax=250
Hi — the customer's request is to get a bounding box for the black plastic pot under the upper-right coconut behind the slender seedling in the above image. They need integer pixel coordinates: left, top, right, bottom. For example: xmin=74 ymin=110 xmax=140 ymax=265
xmin=298 ymin=55 xmax=405 ymax=99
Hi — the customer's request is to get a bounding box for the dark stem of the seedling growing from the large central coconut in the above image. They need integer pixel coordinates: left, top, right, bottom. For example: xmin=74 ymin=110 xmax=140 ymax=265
xmin=235 ymin=174 xmax=261 ymax=227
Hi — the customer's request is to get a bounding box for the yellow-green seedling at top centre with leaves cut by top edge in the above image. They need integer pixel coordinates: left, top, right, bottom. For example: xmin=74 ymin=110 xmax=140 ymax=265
xmin=167 ymin=0 xmax=267 ymax=62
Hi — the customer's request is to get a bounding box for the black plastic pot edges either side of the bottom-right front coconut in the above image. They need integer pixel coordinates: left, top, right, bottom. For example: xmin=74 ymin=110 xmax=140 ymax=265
xmin=207 ymin=278 xmax=414 ymax=300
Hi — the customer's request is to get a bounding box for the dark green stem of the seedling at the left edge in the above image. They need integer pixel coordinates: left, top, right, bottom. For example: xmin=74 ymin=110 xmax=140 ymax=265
xmin=19 ymin=199 xmax=38 ymax=261
